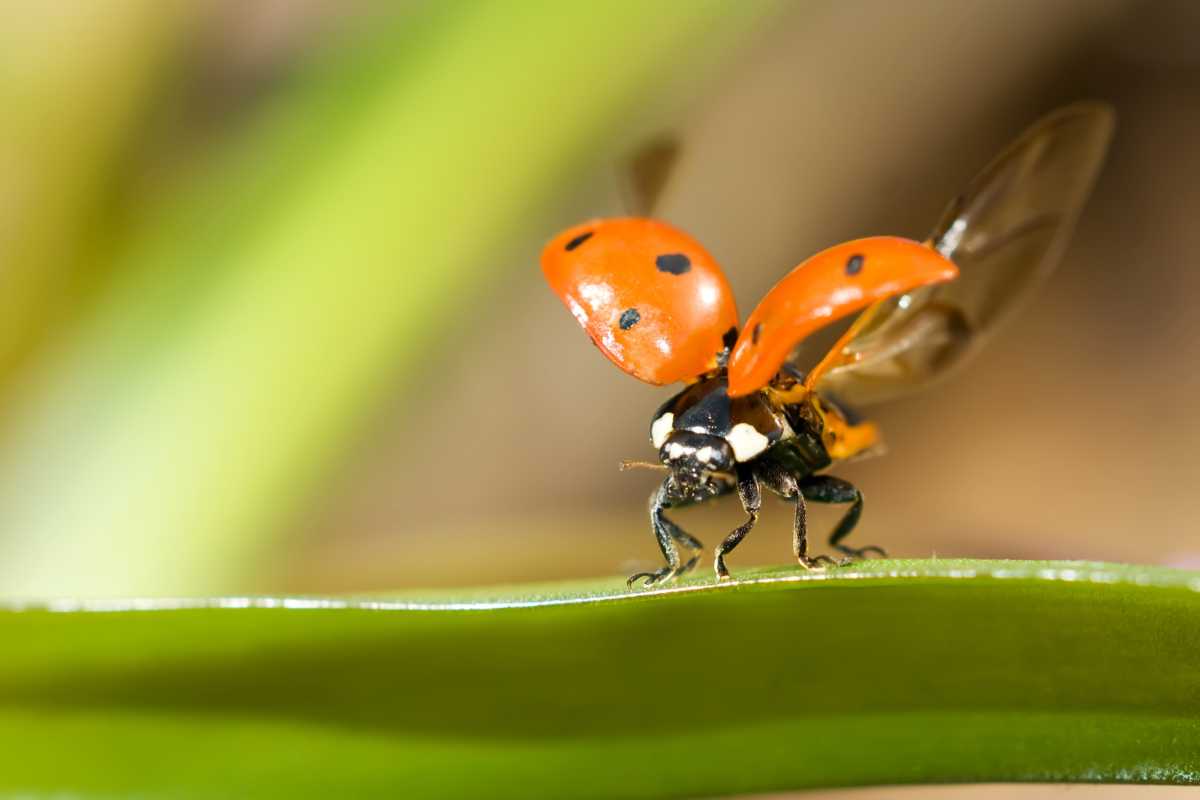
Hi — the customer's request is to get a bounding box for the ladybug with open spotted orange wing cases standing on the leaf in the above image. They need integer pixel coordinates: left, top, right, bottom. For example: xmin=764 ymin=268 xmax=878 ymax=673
xmin=541 ymin=103 xmax=1115 ymax=585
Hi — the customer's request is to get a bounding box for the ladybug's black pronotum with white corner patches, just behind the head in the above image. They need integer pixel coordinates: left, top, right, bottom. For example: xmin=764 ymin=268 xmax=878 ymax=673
xmin=650 ymin=374 xmax=794 ymax=463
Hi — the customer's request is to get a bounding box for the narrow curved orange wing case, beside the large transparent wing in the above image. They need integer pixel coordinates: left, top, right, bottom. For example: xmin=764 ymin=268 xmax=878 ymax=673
xmin=728 ymin=236 xmax=959 ymax=397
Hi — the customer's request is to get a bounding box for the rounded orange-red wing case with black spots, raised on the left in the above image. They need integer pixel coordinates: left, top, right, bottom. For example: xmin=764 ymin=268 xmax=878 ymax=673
xmin=541 ymin=218 xmax=738 ymax=385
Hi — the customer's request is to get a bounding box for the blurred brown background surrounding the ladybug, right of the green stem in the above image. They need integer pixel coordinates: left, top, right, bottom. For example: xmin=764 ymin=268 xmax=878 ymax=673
xmin=283 ymin=0 xmax=1200 ymax=590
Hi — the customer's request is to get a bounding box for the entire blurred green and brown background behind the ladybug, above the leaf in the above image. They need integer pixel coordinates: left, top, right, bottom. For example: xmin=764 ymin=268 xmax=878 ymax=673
xmin=0 ymin=0 xmax=1200 ymax=606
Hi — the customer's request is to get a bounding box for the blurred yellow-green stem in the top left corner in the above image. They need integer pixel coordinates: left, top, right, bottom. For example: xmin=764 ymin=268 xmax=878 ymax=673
xmin=0 ymin=0 xmax=197 ymax=389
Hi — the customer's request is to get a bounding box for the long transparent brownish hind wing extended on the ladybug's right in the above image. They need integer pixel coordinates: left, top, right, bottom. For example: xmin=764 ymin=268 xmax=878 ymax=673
xmin=797 ymin=103 xmax=1115 ymax=404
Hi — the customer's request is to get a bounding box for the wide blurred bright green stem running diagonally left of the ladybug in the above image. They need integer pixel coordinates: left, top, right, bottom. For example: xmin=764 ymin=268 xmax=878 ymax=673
xmin=0 ymin=0 xmax=772 ymax=595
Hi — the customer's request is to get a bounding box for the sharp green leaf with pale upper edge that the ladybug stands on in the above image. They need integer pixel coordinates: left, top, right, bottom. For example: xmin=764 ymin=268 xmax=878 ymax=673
xmin=0 ymin=560 xmax=1200 ymax=798
